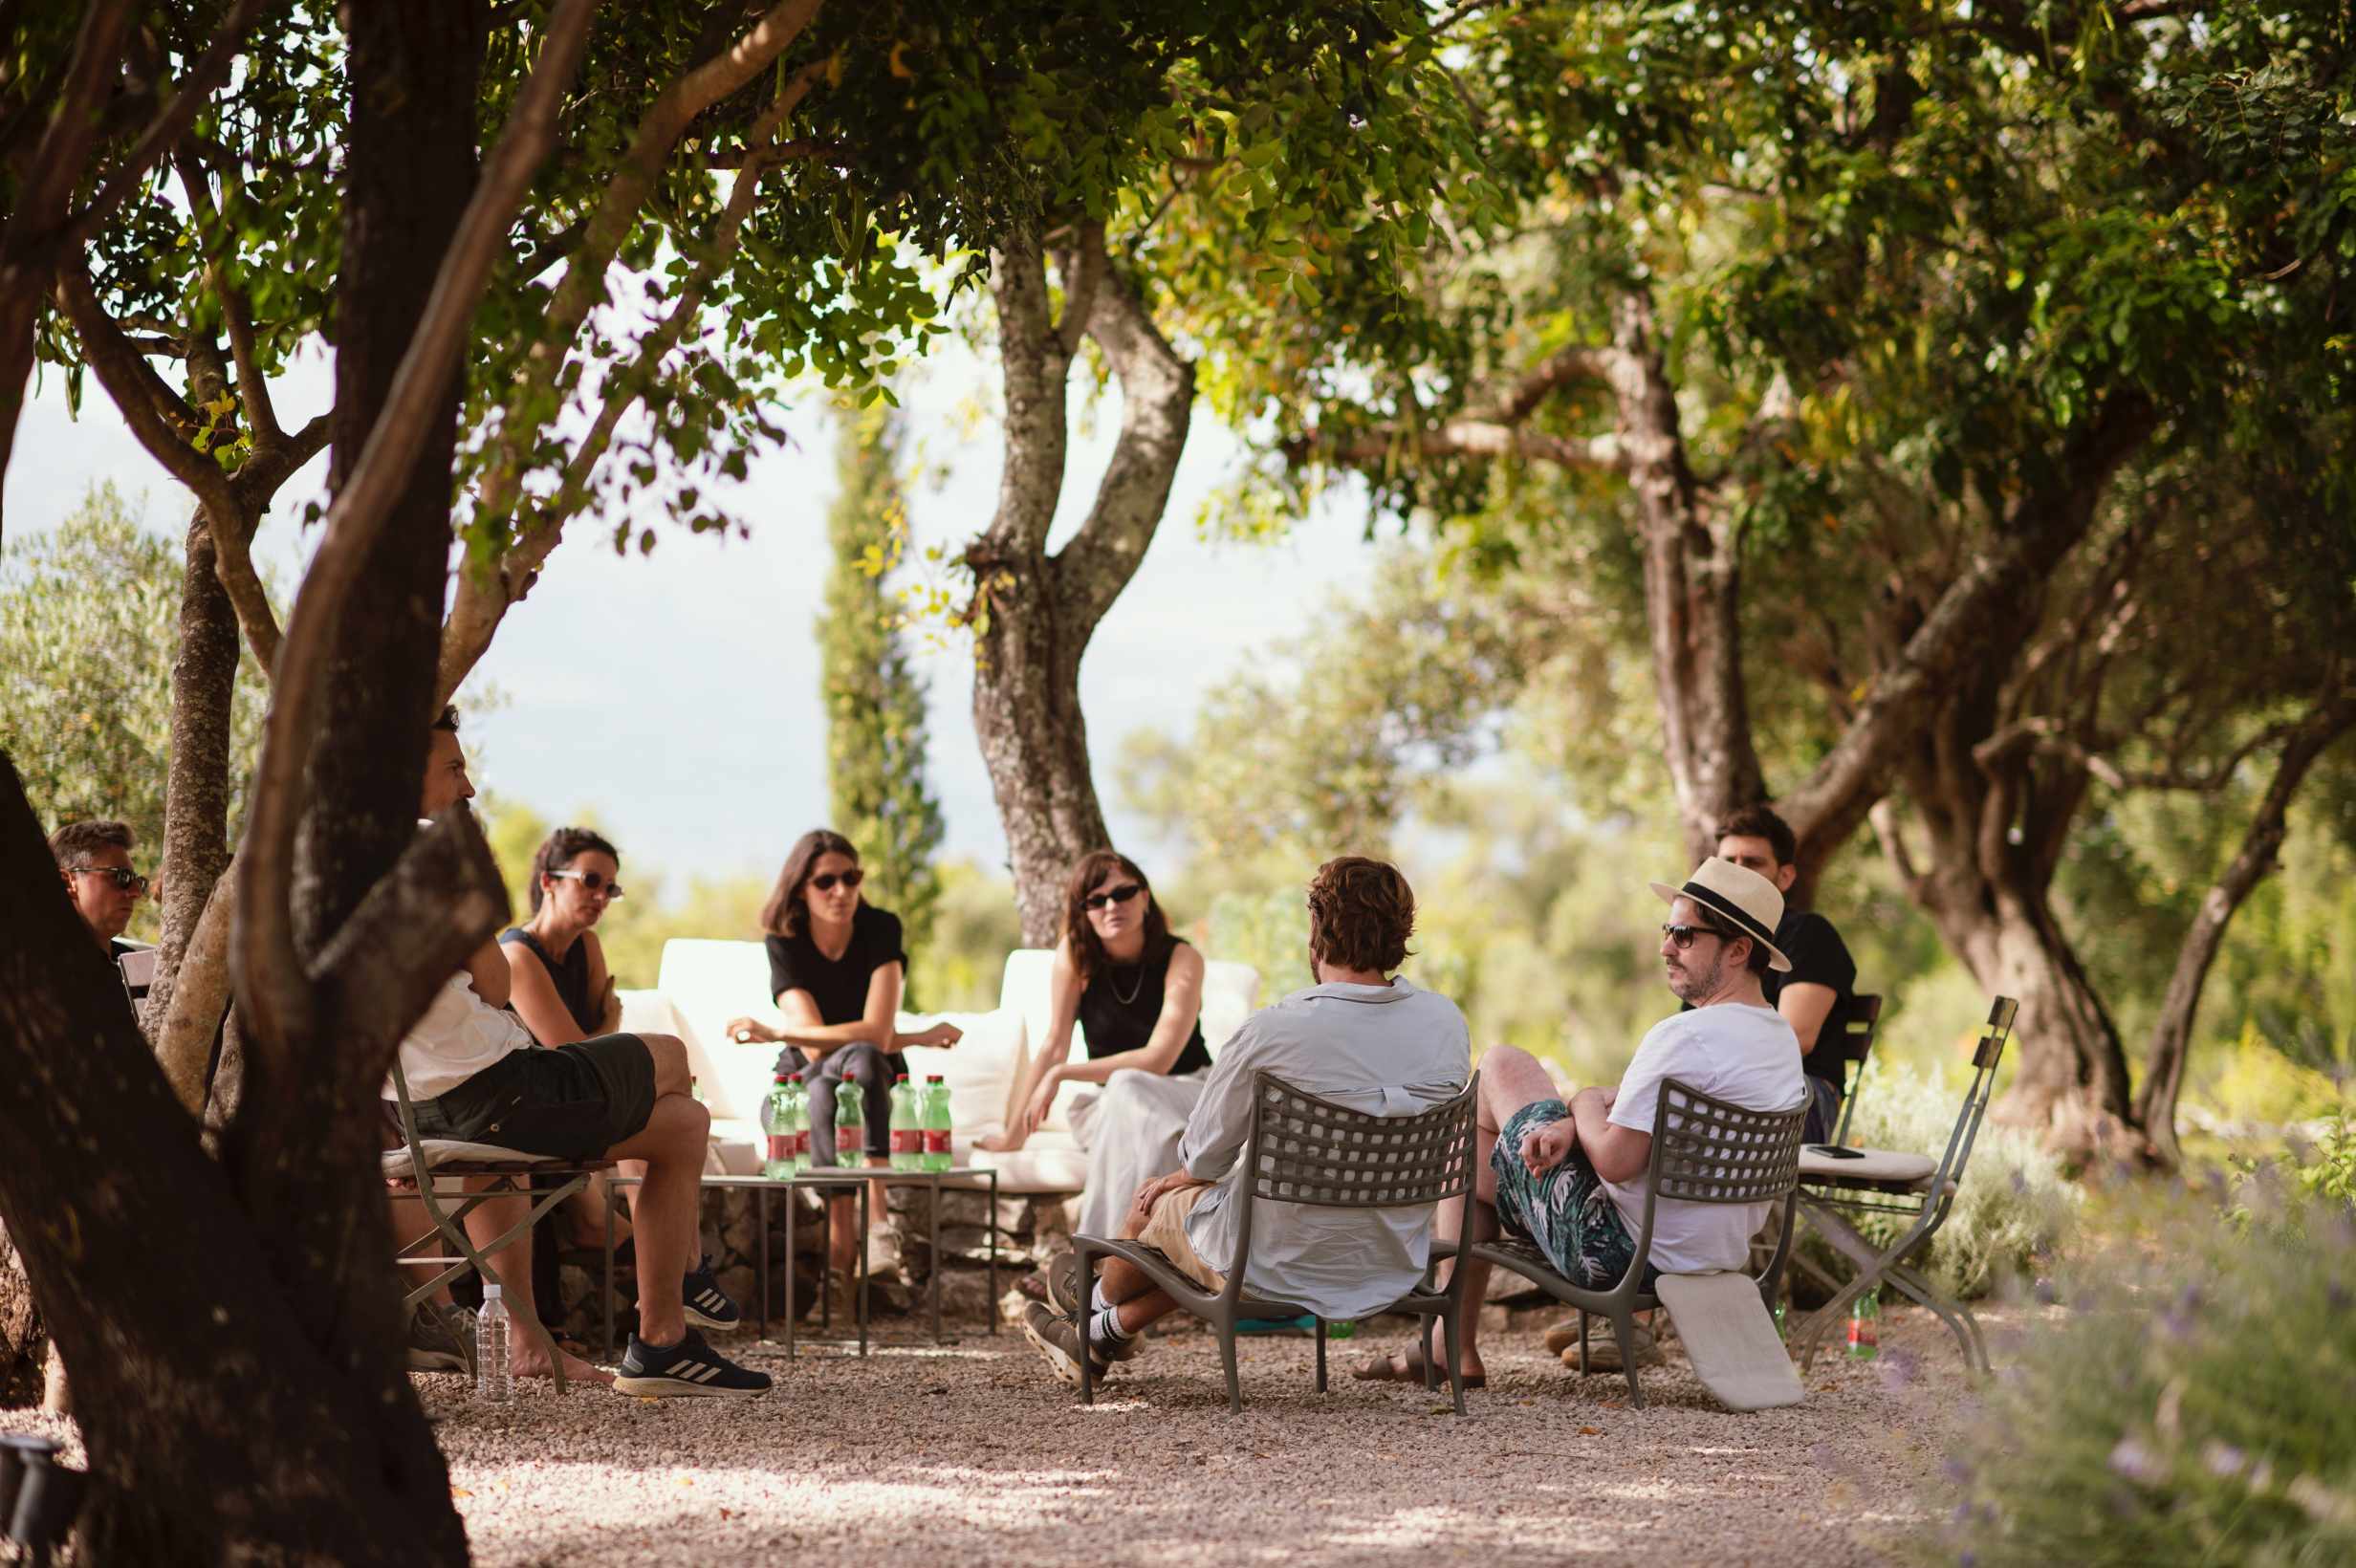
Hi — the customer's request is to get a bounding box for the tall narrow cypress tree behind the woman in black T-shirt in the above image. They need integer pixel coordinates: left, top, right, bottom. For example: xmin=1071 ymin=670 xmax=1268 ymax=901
xmin=818 ymin=409 xmax=943 ymax=993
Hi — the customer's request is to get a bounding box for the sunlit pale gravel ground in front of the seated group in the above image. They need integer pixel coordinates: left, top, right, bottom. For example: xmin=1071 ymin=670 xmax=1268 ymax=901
xmin=0 ymin=1312 xmax=2007 ymax=1568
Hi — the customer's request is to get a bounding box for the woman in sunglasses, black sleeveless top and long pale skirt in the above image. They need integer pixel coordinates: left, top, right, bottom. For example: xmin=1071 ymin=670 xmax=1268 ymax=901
xmin=980 ymin=850 xmax=1211 ymax=1236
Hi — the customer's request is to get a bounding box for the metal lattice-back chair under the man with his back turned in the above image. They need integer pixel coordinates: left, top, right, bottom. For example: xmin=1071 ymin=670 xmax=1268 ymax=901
xmin=1072 ymin=1071 xmax=1479 ymax=1415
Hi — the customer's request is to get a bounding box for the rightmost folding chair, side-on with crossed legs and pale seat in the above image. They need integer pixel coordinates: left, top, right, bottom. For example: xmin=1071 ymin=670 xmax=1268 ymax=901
xmin=1793 ymin=996 xmax=2021 ymax=1373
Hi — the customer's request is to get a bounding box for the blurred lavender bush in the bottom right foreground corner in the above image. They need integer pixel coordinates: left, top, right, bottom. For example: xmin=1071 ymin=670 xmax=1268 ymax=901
xmin=1925 ymin=1185 xmax=2356 ymax=1568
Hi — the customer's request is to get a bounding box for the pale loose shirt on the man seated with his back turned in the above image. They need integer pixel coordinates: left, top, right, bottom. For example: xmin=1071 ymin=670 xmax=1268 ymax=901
xmin=1178 ymin=979 xmax=1470 ymax=1320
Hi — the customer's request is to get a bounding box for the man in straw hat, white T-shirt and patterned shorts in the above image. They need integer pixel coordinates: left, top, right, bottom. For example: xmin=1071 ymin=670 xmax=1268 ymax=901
xmin=1395 ymin=857 xmax=1807 ymax=1386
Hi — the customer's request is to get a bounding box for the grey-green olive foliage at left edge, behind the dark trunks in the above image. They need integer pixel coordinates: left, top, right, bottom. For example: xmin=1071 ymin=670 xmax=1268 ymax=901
xmin=0 ymin=483 xmax=266 ymax=932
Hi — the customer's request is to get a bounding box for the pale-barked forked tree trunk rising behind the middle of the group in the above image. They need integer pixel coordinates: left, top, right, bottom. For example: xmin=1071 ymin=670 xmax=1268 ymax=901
xmin=966 ymin=229 xmax=1194 ymax=947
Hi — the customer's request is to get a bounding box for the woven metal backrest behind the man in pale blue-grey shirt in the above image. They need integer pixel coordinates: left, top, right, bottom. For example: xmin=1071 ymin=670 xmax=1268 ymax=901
xmin=1249 ymin=1071 xmax=1474 ymax=1208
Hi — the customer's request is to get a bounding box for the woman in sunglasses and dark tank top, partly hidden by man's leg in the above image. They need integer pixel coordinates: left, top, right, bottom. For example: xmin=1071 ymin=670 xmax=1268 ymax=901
xmin=499 ymin=826 xmax=645 ymax=1261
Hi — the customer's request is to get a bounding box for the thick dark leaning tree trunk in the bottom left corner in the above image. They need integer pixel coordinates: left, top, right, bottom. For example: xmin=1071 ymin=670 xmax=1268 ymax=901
xmin=0 ymin=752 xmax=467 ymax=1563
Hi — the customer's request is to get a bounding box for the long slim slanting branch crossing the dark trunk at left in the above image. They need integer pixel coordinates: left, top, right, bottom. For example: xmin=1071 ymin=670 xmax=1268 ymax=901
xmin=229 ymin=0 xmax=596 ymax=1053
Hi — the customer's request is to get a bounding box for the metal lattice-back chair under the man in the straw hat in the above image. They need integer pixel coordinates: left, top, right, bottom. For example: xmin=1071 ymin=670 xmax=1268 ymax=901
xmin=1456 ymin=1078 xmax=1809 ymax=1410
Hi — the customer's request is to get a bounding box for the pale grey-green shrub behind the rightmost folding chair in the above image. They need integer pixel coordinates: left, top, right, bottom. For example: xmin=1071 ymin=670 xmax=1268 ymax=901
xmin=1800 ymin=1053 xmax=2078 ymax=1297
